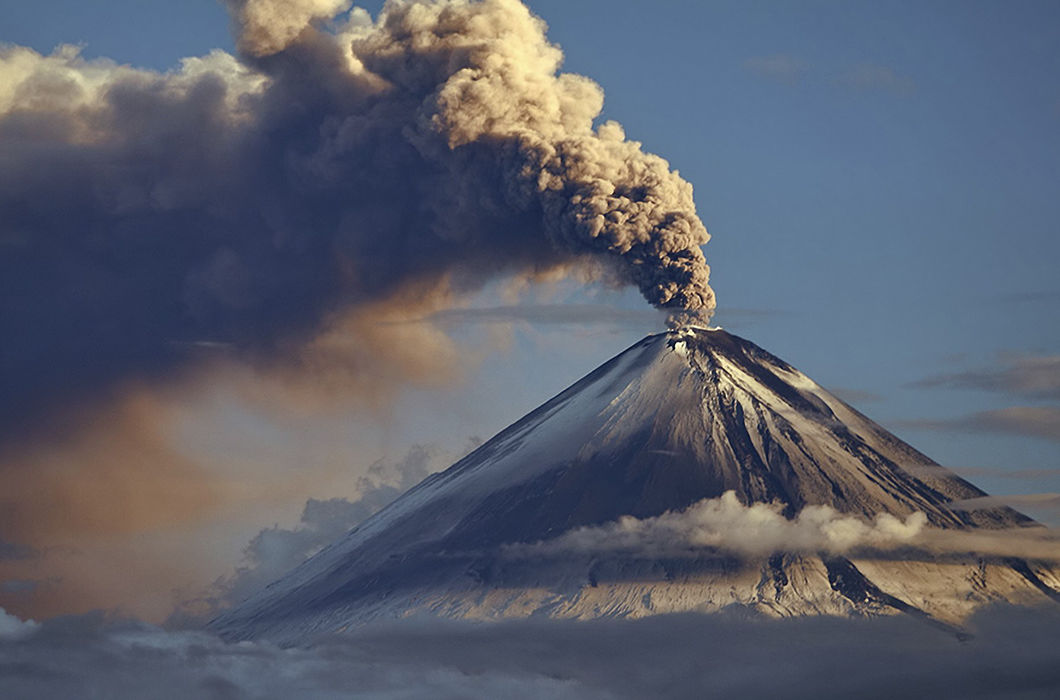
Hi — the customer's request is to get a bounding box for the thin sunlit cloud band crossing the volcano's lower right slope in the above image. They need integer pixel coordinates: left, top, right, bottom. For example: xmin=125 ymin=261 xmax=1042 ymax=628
xmin=507 ymin=491 xmax=1060 ymax=561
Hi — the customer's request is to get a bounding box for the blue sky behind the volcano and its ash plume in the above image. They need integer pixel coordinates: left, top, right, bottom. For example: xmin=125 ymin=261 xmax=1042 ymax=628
xmin=0 ymin=0 xmax=1060 ymax=619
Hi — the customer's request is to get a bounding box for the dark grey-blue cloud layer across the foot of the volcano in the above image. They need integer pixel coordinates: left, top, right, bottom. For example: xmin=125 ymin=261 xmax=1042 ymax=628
xmin=0 ymin=607 xmax=1060 ymax=700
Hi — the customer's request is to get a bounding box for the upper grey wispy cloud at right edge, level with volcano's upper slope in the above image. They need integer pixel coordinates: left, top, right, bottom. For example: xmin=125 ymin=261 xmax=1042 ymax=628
xmin=912 ymin=353 xmax=1060 ymax=400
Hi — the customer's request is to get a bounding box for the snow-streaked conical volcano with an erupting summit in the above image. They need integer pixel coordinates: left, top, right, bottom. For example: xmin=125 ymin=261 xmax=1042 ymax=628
xmin=211 ymin=328 xmax=1060 ymax=644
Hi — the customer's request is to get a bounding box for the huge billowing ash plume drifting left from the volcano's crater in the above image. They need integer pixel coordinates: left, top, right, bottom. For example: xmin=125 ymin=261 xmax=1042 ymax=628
xmin=0 ymin=0 xmax=714 ymax=430
